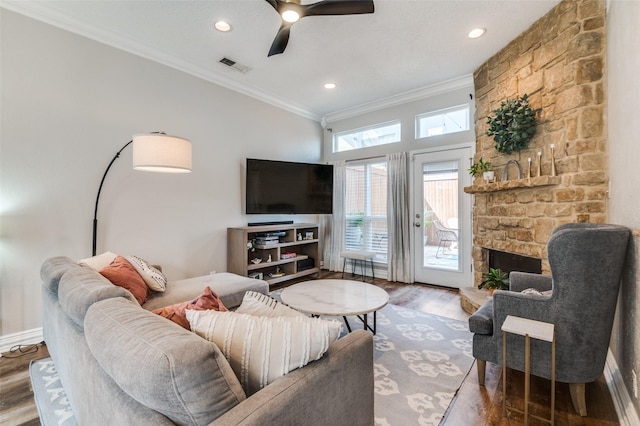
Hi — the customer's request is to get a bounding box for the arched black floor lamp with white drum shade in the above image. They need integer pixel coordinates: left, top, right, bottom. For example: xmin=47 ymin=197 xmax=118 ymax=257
xmin=92 ymin=132 xmax=191 ymax=256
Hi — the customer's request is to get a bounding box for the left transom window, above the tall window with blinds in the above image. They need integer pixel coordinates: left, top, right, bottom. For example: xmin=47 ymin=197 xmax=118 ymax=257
xmin=333 ymin=120 xmax=400 ymax=152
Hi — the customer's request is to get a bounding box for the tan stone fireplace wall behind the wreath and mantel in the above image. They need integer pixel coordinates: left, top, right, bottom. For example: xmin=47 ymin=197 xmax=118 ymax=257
xmin=468 ymin=0 xmax=608 ymax=285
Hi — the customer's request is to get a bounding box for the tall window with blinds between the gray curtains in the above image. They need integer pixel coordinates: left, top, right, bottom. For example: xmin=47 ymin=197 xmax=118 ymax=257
xmin=345 ymin=159 xmax=387 ymax=262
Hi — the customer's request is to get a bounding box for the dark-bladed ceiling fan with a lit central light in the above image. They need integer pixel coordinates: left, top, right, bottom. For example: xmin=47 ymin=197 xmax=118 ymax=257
xmin=265 ymin=0 xmax=373 ymax=56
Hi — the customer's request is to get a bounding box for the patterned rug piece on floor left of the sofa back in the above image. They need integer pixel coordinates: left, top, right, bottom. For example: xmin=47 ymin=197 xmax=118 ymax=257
xmin=29 ymin=358 xmax=78 ymax=426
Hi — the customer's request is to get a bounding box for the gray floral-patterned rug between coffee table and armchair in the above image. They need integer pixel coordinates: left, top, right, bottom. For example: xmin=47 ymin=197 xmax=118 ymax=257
xmin=348 ymin=305 xmax=473 ymax=426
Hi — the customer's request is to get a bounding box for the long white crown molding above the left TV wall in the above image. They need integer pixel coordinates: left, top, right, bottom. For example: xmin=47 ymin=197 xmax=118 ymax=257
xmin=0 ymin=0 xmax=321 ymax=122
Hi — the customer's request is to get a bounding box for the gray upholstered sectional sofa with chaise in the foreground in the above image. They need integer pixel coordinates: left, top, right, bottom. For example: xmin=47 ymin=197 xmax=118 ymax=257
xmin=41 ymin=257 xmax=374 ymax=426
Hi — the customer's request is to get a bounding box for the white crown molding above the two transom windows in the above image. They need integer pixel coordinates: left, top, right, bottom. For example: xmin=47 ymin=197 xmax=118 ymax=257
xmin=321 ymin=74 xmax=473 ymax=124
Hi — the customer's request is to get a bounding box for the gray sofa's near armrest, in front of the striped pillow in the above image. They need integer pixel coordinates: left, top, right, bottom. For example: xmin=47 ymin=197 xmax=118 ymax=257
xmin=211 ymin=330 xmax=374 ymax=426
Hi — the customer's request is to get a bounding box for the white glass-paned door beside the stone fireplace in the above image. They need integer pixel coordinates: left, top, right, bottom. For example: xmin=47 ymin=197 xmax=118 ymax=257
xmin=412 ymin=146 xmax=473 ymax=288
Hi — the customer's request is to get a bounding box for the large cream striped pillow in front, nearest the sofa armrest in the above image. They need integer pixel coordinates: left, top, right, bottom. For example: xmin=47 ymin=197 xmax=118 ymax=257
xmin=186 ymin=310 xmax=342 ymax=395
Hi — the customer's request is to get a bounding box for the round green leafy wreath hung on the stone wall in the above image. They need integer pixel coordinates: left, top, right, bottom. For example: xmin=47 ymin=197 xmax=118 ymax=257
xmin=486 ymin=94 xmax=541 ymax=154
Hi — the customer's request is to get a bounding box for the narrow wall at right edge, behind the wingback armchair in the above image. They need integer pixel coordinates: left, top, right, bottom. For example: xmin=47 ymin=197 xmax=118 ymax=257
xmin=607 ymin=0 xmax=640 ymax=424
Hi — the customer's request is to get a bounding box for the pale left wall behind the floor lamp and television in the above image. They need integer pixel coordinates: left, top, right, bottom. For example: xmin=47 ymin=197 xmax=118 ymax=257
xmin=0 ymin=9 xmax=322 ymax=335
